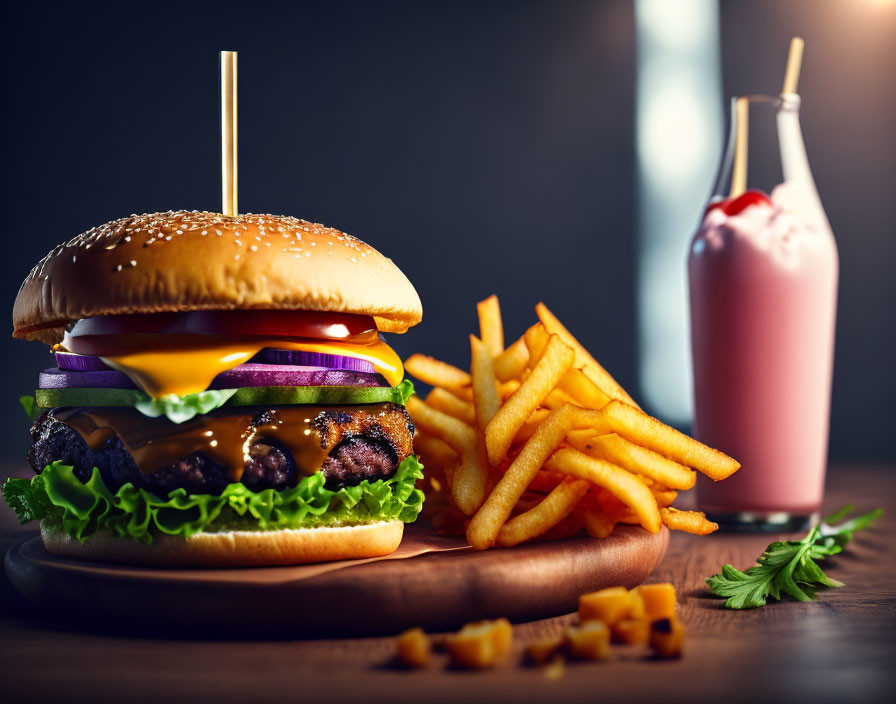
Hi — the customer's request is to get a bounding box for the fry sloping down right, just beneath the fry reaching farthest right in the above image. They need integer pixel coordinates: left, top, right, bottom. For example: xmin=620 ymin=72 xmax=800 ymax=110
xmin=567 ymin=430 xmax=697 ymax=489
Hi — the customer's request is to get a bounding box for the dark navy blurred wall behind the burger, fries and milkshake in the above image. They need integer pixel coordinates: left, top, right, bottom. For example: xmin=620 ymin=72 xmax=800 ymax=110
xmin=0 ymin=0 xmax=896 ymax=460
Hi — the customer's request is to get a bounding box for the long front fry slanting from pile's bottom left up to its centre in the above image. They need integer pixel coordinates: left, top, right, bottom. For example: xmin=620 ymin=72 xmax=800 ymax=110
xmin=467 ymin=406 xmax=576 ymax=550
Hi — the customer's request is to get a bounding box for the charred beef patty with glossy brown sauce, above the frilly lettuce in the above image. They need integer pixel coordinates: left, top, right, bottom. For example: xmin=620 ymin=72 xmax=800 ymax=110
xmin=28 ymin=404 xmax=414 ymax=496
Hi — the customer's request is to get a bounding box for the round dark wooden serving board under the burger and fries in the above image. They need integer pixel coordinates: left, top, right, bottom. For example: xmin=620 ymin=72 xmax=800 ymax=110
xmin=6 ymin=526 xmax=669 ymax=638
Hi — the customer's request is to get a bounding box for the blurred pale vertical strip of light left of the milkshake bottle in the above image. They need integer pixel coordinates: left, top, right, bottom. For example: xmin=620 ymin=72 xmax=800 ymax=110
xmin=635 ymin=0 xmax=723 ymax=425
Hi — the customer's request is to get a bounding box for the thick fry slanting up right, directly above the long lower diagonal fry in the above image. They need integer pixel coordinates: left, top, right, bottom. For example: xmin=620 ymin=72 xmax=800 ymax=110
xmin=485 ymin=336 xmax=575 ymax=466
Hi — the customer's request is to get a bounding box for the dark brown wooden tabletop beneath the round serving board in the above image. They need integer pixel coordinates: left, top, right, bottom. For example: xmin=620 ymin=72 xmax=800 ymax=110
xmin=0 ymin=466 xmax=896 ymax=704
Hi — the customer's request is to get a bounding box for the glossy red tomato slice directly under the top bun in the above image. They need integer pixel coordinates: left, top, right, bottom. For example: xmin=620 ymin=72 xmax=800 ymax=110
xmin=68 ymin=310 xmax=376 ymax=340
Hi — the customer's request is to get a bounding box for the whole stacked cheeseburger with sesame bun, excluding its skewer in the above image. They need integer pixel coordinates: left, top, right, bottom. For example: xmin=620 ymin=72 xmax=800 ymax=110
xmin=3 ymin=211 xmax=423 ymax=566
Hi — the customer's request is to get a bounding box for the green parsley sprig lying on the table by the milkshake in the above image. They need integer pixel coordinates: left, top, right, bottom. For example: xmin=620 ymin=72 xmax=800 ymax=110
xmin=706 ymin=505 xmax=883 ymax=609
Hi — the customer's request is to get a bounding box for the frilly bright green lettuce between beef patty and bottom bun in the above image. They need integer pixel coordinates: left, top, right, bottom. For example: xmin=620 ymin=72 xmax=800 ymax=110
xmin=3 ymin=455 xmax=423 ymax=543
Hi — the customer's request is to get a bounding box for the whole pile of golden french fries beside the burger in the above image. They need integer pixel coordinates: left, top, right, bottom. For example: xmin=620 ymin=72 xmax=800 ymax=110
xmin=405 ymin=296 xmax=740 ymax=550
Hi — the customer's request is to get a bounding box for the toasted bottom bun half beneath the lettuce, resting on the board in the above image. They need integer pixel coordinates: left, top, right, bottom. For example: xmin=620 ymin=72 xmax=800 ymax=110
xmin=40 ymin=521 xmax=404 ymax=567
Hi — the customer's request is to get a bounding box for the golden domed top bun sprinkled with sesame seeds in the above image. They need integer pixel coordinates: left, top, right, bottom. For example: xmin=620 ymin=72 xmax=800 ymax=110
xmin=13 ymin=210 xmax=423 ymax=344
